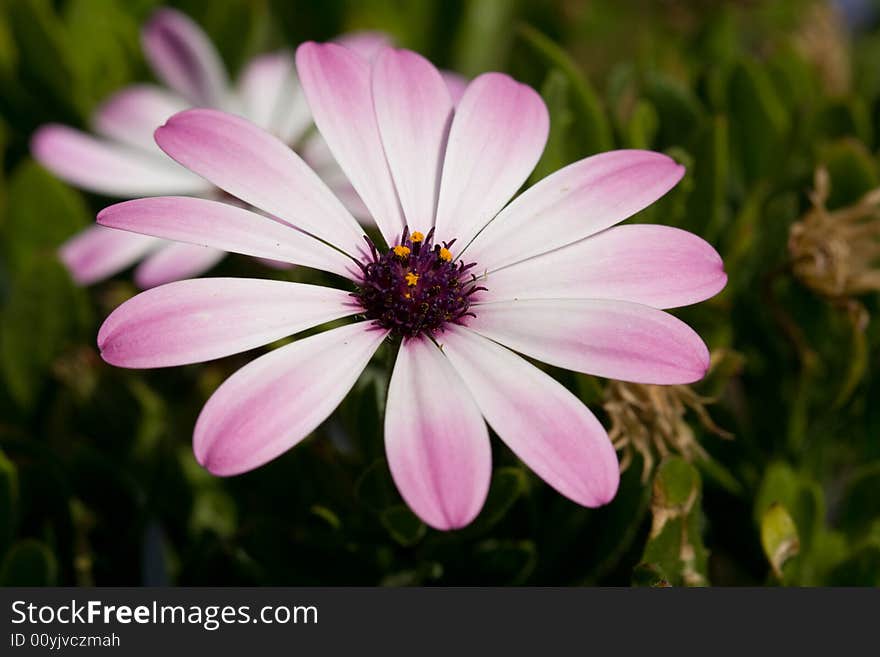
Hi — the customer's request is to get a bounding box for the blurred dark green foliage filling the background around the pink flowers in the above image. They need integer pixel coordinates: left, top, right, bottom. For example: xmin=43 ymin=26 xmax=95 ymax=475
xmin=0 ymin=0 xmax=880 ymax=585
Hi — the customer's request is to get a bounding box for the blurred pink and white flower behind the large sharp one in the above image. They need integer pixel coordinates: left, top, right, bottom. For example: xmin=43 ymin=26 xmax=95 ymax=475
xmin=32 ymin=9 xmax=387 ymax=288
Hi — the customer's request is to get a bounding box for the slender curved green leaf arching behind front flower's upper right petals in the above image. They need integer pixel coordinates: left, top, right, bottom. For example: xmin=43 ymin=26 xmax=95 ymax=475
xmin=519 ymin=25 xmax=612 ymax=159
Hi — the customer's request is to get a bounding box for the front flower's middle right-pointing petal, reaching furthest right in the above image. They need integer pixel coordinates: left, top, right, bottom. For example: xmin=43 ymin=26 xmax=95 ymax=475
xmin=483 ymin=224 xmax=727 ymax=308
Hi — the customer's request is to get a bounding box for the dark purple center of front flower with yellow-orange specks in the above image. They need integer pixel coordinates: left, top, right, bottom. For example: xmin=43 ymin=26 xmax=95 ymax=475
xmin=353 ymin=228 xmax=486 ymax=338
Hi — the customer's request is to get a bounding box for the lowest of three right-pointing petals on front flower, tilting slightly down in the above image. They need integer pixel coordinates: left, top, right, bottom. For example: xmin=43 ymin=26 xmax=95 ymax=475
xmin=468 ymin=299 xmax=709 ymax=384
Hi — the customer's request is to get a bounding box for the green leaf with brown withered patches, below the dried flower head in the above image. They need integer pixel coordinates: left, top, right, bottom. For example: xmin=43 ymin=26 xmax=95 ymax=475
xmin=642 ymin=457 xmax=708 ymax=586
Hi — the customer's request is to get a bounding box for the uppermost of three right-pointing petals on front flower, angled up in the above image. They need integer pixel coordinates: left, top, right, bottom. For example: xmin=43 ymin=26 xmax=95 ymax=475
xmin=467 ymin=150 xmax=684 ymax=271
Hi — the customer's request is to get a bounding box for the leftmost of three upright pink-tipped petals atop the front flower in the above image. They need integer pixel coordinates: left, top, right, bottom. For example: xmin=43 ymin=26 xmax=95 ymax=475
xmin=296 ymin=42 xmax=404 ymax=244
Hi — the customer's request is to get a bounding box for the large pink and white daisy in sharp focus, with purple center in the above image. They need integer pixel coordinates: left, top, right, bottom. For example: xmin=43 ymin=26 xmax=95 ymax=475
xmin=98 ymin=43 xmax=726 ymax=529
